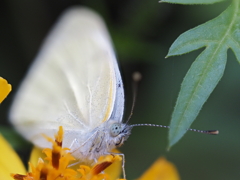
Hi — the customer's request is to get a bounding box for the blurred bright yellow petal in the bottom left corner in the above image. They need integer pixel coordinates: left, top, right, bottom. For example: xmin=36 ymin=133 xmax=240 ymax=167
xmin=0 ymin=134 xmax=26 ymax=180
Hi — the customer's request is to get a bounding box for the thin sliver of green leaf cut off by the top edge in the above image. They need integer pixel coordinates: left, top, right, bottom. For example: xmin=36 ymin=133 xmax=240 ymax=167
xmin=159 ymin=0 xmax=226 ymax=4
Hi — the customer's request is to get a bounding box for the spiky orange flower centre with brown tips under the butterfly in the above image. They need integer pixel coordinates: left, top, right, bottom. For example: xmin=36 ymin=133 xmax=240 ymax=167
xmin=12 ymin=126 xmax=121 ymax=180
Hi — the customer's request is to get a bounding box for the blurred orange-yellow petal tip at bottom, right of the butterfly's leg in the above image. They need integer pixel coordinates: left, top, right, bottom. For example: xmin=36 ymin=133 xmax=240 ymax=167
xmin=138 ymin=157 xmax=180 ymax=180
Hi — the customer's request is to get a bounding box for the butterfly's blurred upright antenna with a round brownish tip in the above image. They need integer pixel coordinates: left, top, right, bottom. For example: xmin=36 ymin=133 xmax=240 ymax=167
xmin=126 ymin=71 xmax=142 ymax=124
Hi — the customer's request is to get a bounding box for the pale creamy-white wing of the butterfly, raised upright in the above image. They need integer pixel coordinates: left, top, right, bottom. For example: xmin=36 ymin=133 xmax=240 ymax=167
xmin=10 ymin=7 xmax=124 ymax=147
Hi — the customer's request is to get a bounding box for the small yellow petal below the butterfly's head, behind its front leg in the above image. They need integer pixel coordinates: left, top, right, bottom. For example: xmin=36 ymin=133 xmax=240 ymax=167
xmin=104 ymin=149 xmax=122 ymax=180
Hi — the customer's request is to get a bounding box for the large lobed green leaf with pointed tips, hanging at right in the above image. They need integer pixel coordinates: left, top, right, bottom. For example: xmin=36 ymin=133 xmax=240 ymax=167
xmin=167 ymin=0 xmax=240 ymax=148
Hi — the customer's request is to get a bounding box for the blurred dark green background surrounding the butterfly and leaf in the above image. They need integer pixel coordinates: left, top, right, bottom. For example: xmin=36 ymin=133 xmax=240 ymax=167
xmin=0 ymin=0 xmax=240 ymax=180
